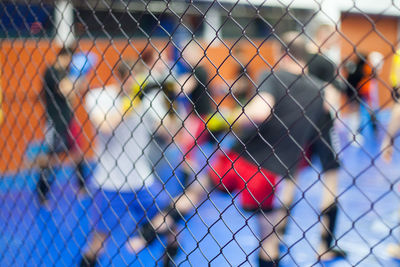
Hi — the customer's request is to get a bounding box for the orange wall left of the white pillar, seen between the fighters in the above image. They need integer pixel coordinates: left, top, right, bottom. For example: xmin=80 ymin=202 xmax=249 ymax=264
xmin=0 ymin=39 xmax=274 ymax=172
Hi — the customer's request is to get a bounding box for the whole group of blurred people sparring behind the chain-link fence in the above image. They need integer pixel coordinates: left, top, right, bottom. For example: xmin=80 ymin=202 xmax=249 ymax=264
xmin=29 ymin=25 xmax=400 ymax=266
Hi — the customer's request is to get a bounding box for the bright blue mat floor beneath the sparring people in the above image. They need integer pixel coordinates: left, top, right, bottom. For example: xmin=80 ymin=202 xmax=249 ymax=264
xmin=0 ymin=110 xmax=400 ymax=266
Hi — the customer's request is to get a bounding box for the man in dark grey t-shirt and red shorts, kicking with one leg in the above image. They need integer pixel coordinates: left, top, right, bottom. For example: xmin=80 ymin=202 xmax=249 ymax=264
xmin=129 ymin=32 xmax=332 ymax=266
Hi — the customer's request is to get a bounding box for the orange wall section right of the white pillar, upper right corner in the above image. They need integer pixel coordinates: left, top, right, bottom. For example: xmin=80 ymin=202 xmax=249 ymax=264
xmin=341 ymin=14 xmax=398 ymax=107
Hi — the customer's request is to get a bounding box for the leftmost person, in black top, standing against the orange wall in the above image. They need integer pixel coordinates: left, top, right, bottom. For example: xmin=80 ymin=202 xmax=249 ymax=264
xmin=35 ymin=47 xmax=85 ymax=204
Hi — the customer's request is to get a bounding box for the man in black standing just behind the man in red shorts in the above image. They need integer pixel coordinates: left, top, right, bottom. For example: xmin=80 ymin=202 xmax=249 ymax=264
xmin=278 ymin=24 xmax=346 ymax=260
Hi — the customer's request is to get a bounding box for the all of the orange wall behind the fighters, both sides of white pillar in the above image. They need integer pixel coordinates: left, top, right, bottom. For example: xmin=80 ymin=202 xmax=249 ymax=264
xmin=0 ymin=14 xmax=398 ymax=172
